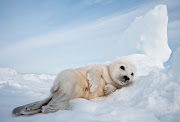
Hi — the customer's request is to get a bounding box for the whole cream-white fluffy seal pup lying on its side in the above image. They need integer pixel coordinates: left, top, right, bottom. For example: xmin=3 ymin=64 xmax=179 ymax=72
xmin=12 ymin=58 xmax=136 ymax=116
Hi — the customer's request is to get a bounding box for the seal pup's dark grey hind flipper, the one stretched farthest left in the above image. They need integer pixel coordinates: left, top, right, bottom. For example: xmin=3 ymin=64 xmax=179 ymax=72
xmin=12 ymin=96 xmax=52 ymax=116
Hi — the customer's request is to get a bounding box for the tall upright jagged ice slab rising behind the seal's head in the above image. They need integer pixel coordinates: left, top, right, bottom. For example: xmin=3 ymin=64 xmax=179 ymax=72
xmin=118 ymin=5 xmax=171 ymax=67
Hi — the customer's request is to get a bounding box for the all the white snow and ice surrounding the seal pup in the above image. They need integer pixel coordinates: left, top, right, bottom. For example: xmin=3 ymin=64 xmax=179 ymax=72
xmin=0 ymin=5 xmax=180 ymax=122
